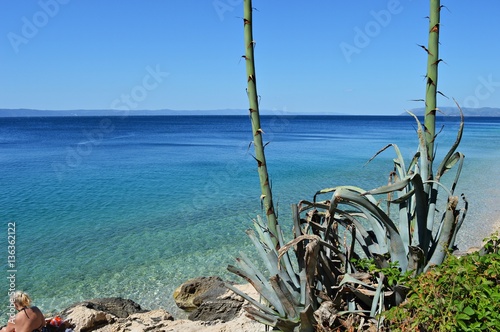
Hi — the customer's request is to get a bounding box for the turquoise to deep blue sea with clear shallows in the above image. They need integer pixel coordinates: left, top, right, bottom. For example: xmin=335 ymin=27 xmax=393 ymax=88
xmin=0 ymin=115 xmax=500 ymax=325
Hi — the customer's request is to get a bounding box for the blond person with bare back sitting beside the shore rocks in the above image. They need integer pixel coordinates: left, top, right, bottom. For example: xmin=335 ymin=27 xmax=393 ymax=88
xmin=0 ymin=291 xmax=45 ymax=332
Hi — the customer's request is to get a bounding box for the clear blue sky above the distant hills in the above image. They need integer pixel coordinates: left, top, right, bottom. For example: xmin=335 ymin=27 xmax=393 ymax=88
xmin=0 ymin=0 xmax=500 ymax=115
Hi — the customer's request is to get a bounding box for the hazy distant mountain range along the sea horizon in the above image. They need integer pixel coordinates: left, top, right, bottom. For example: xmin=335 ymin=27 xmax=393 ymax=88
xmin=0 ymin=107 xmax=500 ymax=117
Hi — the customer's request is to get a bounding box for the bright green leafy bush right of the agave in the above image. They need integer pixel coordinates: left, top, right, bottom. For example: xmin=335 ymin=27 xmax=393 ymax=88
xmin=383 ymin=234 xmax=500 ymax=331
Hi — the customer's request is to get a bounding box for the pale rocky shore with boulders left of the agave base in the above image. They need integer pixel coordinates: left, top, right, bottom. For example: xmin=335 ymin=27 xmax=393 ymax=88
xmin=42 ymin=277 xmax=265 ymax=332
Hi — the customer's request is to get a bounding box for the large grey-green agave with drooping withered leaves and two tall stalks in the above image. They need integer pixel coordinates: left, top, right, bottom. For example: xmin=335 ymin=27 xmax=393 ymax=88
xmin=227 ymin=0 xmax=468 ymax=331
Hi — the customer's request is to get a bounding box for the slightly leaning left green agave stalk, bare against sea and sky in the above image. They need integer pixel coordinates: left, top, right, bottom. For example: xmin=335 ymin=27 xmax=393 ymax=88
xmin=243 ymin=0 xmax=278 ymax=246
